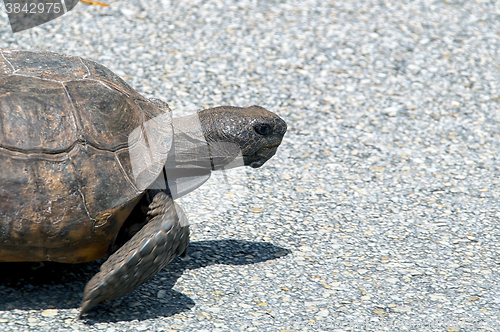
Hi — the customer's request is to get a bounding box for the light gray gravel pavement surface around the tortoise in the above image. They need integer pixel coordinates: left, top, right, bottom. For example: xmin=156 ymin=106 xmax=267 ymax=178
xmin=0 ymin=0 xmax=500 ymax=332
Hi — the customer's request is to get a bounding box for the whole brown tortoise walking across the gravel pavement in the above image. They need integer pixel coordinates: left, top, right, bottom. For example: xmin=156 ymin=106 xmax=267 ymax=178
xmin=0 ymin=50 xmax=287 ymax=317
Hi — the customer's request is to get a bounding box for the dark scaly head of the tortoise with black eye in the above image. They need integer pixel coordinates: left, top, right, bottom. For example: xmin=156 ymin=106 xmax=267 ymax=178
xmin=198 ymin=106 xmax=286 ymax=169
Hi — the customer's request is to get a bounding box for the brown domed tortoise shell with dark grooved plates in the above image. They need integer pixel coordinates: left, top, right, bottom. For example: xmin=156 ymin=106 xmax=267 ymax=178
xmin=0 ymin=50 xmax=172 ymax=263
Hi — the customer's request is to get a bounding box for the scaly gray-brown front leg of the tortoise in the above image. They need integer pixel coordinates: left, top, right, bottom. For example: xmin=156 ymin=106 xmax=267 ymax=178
xmin=80 ymin=192 xmax=189 ymax=318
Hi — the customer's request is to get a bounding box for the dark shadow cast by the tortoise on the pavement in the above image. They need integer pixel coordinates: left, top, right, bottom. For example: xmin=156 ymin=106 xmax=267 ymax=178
xmin=0 ymin=240 xmax=290 ymax=324
